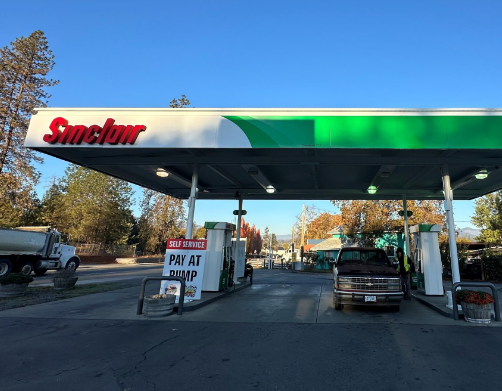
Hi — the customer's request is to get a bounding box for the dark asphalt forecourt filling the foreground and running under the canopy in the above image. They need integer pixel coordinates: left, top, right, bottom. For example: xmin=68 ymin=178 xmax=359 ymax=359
xmin=0 ymin=270 xmax=502 ymax=391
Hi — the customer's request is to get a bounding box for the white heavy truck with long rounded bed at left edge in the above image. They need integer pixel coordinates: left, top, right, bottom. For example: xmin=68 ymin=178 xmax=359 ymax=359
xmin=0 ymin=227 xmax=80 ymax=277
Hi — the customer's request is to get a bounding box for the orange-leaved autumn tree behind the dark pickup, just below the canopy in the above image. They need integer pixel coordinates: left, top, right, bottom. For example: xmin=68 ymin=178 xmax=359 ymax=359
xmin=332 ymin=200 xmax=444 ymax=246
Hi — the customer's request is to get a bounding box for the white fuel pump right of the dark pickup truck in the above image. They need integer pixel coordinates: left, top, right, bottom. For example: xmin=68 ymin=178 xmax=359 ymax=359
xmin=410 ymin=224 xmax=444 ymax=296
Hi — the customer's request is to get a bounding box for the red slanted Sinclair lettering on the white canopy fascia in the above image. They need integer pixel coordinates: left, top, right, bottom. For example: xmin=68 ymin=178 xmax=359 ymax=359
xmin=44 ymin=117 xmax=146 ymax=145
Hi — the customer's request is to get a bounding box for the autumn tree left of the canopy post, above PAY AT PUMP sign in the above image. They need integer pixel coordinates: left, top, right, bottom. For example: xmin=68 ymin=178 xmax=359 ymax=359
xmin=139 ymin=189 xmax=186 ymax=254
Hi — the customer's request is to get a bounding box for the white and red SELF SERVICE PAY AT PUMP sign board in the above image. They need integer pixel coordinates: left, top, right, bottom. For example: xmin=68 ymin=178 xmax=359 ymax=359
xmin=160 ymin=239 xmax=207 ymax=301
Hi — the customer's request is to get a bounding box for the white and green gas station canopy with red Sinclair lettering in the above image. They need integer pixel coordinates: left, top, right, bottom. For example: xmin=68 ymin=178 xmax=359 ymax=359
xmin=25 ymin=108 xmax=502 ymax=200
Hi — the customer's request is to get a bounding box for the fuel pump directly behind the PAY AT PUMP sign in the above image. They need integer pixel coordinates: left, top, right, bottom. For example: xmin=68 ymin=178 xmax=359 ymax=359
xmin=202 ymin=222 xmax=235 ymax=292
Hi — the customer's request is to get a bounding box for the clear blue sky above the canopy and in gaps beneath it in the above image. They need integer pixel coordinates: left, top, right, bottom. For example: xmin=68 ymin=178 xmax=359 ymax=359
xmin=0 ymin=0 xmax=502 ymax=234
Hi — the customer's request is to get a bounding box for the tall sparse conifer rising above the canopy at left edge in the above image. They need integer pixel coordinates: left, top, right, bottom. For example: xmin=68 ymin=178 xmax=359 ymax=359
xmin=0 ymin=30 xmax=58 ymax=226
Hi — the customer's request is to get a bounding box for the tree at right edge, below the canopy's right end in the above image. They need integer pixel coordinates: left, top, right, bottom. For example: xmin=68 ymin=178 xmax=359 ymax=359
xmin=471 ymin=191 xmax=502 ymax=245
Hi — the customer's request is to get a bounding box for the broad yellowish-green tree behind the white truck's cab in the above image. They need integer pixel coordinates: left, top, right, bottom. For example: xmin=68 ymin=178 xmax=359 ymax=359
xmin=49 ymin=165 xmax=134 ymax=244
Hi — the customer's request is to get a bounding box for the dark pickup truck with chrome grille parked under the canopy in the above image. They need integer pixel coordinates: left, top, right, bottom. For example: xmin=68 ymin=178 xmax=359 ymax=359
xmin=333 ymin=247 xmax=403 ymax=311
